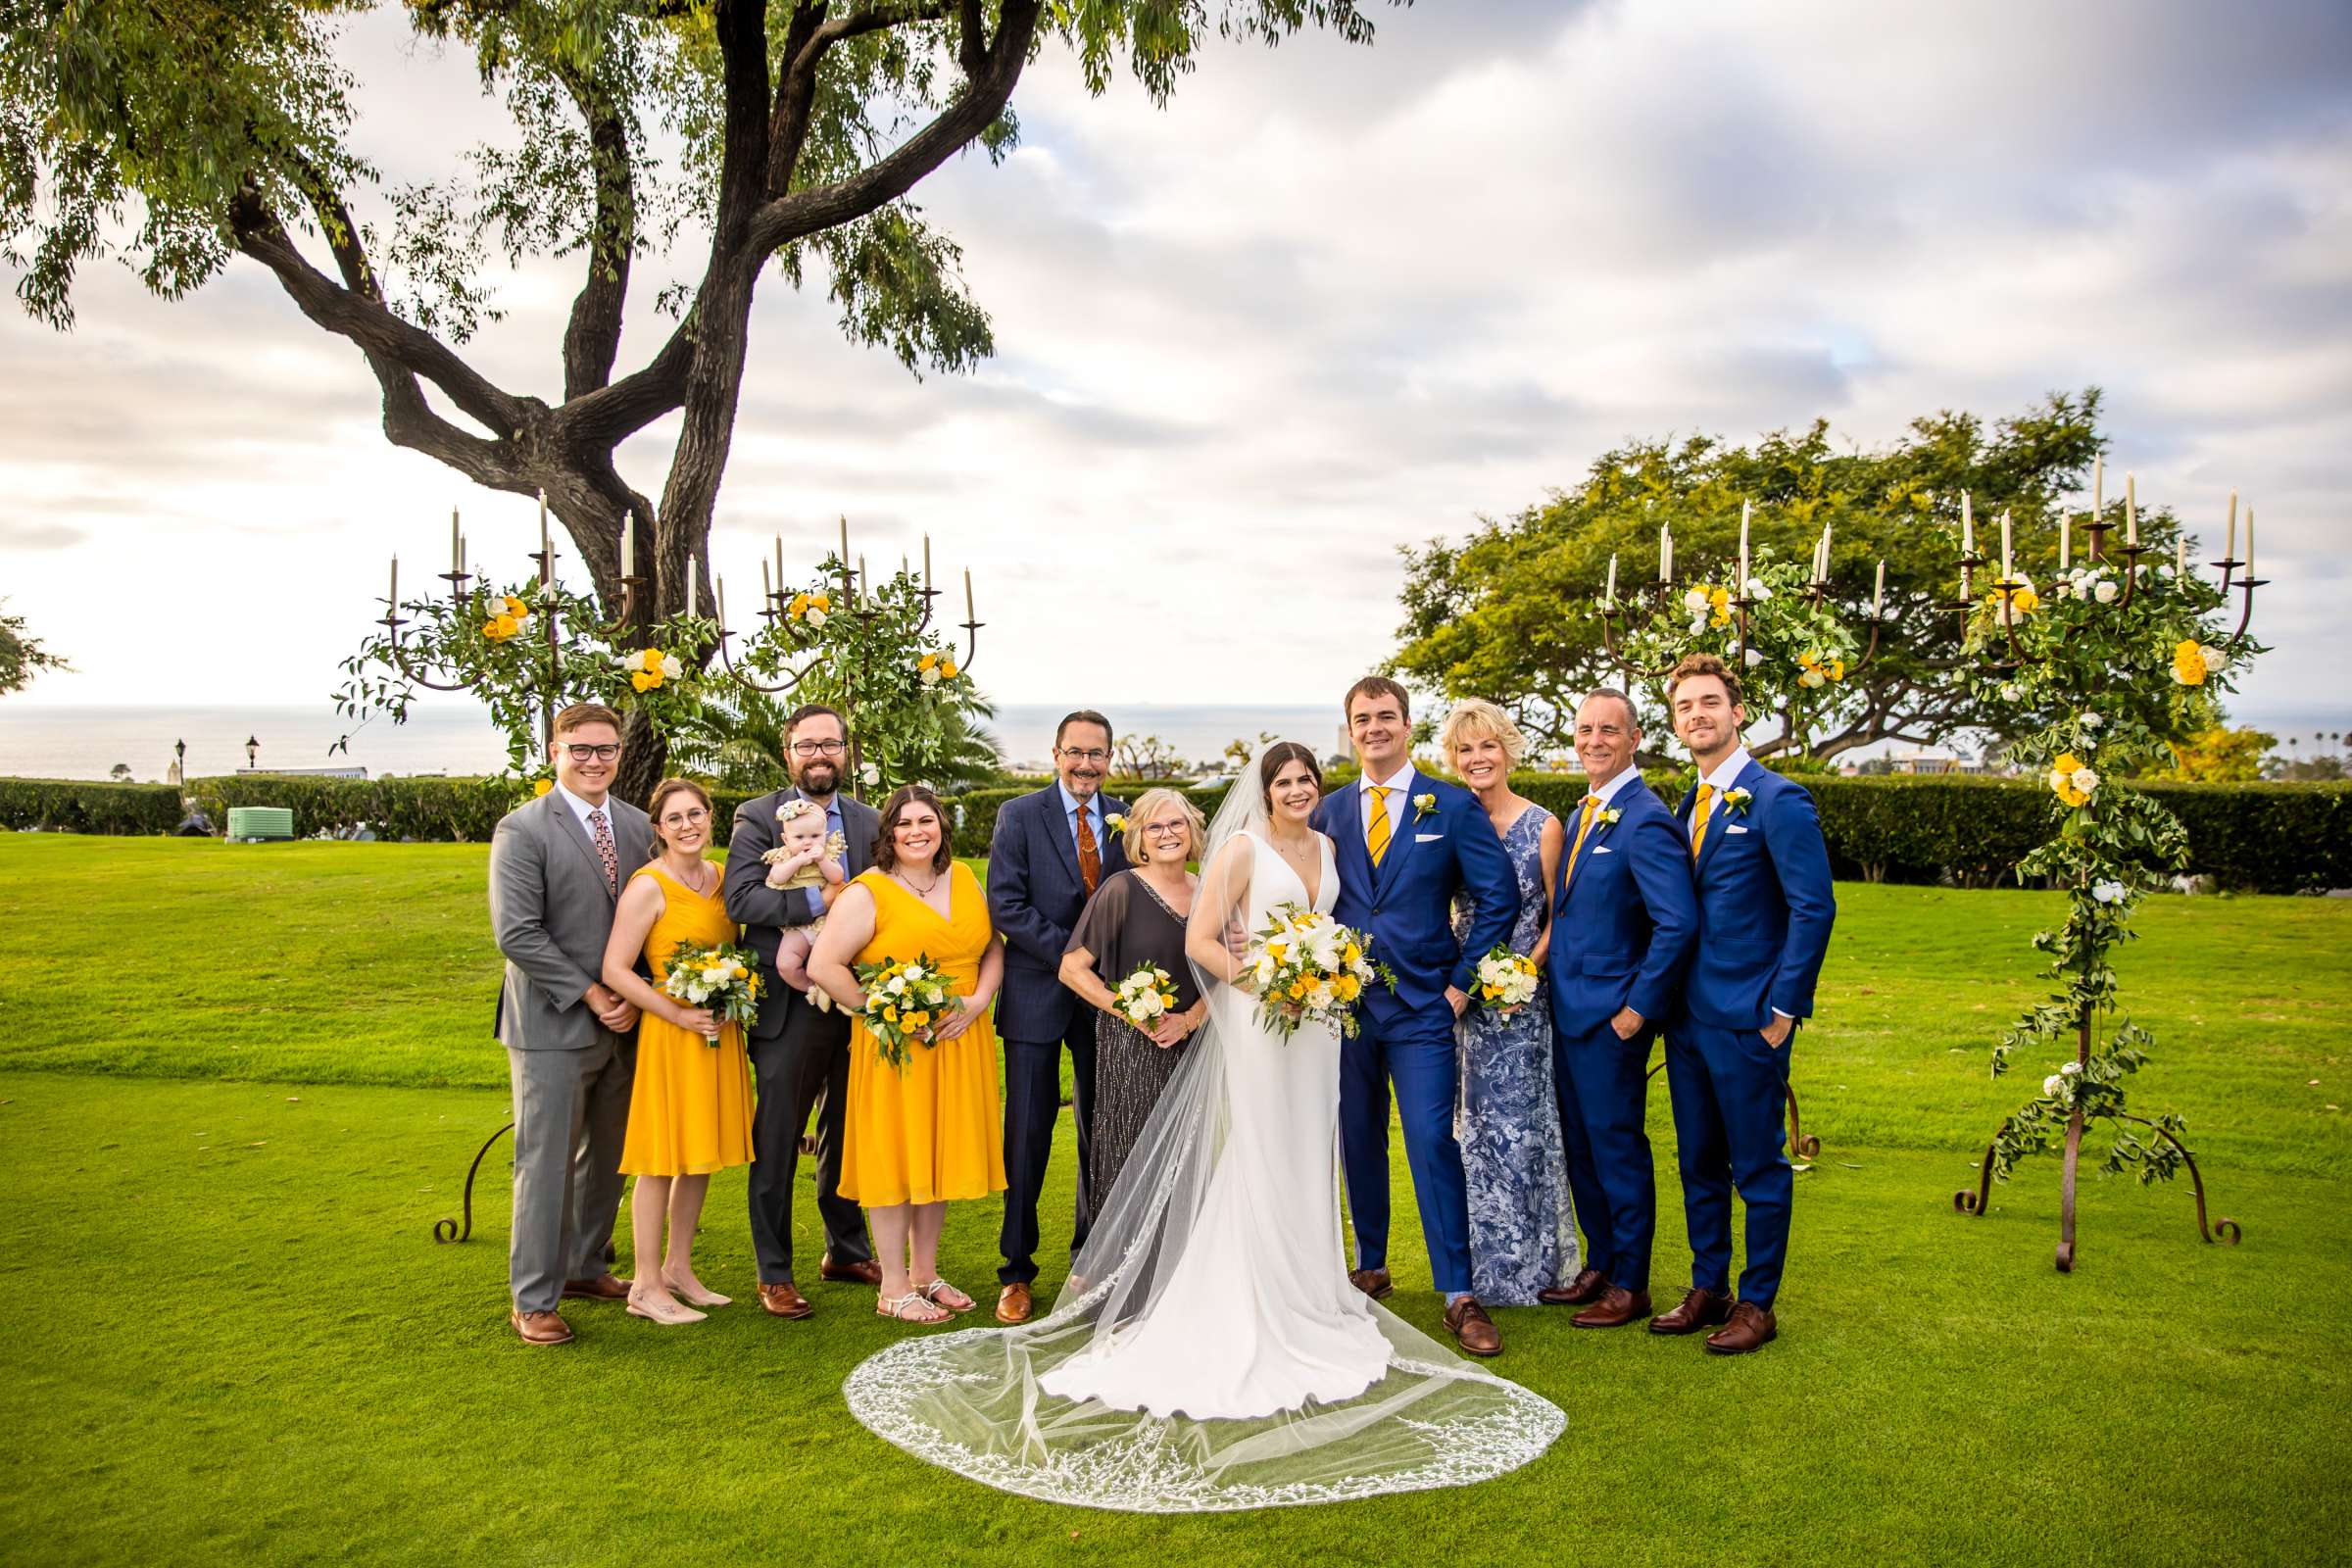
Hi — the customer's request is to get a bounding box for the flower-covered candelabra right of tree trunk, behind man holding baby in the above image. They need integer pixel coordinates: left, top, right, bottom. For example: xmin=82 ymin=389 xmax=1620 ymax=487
xmin=717 ymin=519 xmax=983 ymax=790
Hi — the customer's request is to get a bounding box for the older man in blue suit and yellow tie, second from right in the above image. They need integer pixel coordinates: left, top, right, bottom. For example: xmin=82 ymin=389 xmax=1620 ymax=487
xmin=1539 ymin=691 xmax=1698 ymax=1328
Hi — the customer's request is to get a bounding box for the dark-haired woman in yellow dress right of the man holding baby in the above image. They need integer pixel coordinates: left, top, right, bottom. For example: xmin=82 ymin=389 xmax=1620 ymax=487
xmin=809 ymin=785 xmax=1004 ymax=1324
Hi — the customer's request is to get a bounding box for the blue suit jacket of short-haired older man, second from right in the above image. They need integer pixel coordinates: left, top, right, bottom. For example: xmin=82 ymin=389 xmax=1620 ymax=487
xmin=1543 ymin=776 xmax=1698 ymax=1034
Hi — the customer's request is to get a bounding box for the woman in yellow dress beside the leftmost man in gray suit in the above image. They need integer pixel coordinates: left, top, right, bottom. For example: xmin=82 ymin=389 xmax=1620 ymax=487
xmin=605 ymin=778 xmax=753 ymax=1324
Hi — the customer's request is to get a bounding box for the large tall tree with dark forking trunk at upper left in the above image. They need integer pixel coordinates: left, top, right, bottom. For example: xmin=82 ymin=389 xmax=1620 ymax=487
xmin=0 ymin=0 xmax=1371 ymax=790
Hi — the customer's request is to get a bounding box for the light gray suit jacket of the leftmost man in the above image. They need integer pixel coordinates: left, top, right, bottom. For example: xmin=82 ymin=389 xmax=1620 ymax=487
xmin=489 ymin=790 xmax=654 ymax=1051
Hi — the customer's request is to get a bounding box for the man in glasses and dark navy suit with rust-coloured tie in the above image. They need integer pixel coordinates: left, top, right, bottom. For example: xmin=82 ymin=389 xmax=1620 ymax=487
xmin=988 ymin=710 xmax=1127 ymax=1324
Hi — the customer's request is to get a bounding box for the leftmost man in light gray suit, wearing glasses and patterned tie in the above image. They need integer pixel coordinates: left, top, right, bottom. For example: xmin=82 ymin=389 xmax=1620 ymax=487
xmin=489 ymin=703 xmax=654 ymax=1345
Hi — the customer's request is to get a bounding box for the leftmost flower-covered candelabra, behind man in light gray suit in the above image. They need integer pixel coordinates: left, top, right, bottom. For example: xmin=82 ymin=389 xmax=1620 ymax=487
xmin=334 ymin=494 xmax=717 ymax=780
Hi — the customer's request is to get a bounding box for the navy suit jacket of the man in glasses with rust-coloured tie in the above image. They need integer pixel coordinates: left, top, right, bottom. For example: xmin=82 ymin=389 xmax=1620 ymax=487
xmin=988 ymin=783 xmax=1127 ymax=1044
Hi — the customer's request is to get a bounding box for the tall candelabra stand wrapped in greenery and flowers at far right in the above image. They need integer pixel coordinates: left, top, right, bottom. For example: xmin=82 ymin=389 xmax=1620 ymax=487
xmin=1945 ymin=461 xmax=2263 ymax=1272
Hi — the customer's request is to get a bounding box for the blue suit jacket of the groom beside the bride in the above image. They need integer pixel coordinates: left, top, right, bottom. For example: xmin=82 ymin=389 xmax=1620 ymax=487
xmin=1307 ymin=773 xmax=1519 ymax=1022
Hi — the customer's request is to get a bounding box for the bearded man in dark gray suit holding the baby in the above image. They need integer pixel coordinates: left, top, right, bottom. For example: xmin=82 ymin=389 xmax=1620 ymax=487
xmin=727 ymin=703 xmax=882 ymax=1319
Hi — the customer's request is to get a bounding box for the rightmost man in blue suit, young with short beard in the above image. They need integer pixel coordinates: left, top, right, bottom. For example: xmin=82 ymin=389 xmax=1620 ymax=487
xmin=1648 ymin=654 xmax=1837 ymax=1356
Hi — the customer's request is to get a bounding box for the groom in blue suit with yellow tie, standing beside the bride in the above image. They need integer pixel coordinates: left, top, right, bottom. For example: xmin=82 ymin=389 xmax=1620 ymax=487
xmin=1315 ymin=674 xmax=1519 ymax=1356
